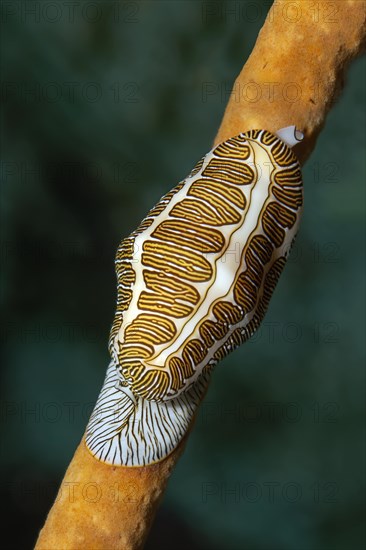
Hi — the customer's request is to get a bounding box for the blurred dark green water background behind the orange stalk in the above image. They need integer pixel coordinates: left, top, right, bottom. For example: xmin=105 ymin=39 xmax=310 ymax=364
xmin=1 ymin=0 xmax=366 ymax=550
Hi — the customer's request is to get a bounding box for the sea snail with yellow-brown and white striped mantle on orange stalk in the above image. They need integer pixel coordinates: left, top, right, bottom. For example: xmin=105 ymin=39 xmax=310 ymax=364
xmin=86 ymin=126 xmax=303 ymax=466
